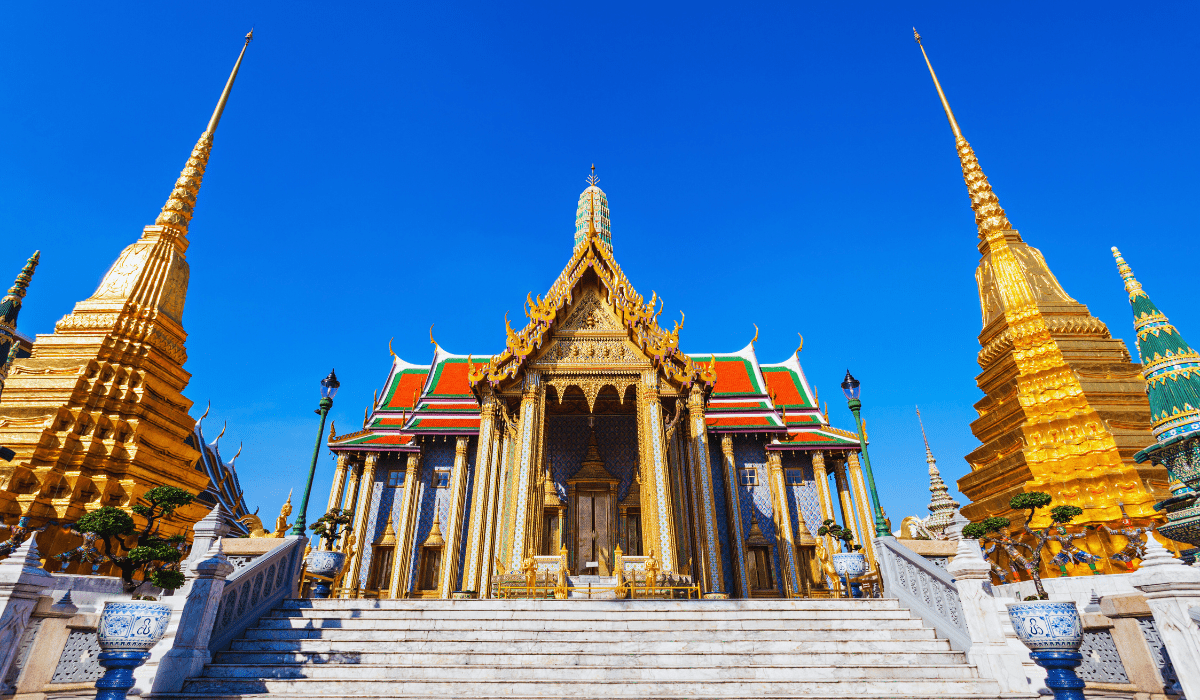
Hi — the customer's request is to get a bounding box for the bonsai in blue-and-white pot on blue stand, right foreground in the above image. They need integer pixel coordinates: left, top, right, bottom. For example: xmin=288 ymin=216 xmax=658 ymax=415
xmin=962 ymin=491 xmax=1084 ymax=698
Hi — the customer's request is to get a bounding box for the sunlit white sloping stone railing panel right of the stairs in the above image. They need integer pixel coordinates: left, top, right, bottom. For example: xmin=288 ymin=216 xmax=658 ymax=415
xmin=875 ymin=537 xmax=971 ymax=652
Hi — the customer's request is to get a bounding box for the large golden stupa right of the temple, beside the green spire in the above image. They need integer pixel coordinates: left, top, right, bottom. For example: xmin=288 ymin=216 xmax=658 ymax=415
xmin=913 ymin=31 xmax=1166 ymax=549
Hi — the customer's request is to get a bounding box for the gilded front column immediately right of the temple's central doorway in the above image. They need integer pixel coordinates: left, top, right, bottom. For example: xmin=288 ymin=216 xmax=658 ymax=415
xmin=637 ymin=370 xmax=676 ymax=573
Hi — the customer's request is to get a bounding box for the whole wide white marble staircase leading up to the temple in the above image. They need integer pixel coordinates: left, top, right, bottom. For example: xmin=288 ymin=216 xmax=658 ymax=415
xmin=170 ymin=599 xmax=1000 ymax=700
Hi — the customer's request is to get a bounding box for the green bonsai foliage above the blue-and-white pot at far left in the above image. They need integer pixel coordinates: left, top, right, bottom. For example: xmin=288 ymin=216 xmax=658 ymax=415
xmin=54 ymin=486 xmax=196 ymax=593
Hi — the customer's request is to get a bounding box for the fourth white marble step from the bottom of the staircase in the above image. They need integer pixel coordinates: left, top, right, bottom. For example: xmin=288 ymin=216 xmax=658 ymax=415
xmin=221 ymin=634 xmax=950 ymax=663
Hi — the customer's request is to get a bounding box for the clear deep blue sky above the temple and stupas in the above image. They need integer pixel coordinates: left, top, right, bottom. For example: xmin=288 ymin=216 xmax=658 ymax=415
xmin=0 ymin=1 xmax=1200 ymax=525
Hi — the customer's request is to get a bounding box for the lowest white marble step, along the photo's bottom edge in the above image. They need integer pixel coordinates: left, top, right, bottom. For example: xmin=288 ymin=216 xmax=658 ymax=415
xmin=184 ymin=672 xmax=998 ymax=698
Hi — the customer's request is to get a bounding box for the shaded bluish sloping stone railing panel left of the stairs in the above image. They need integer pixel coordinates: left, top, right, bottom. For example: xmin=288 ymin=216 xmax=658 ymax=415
xmin=209 ymin=536 xmax=307 ymax=652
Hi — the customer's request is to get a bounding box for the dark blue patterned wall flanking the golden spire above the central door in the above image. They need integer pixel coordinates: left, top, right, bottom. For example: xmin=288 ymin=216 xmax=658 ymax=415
xmin=546 ymin=415 xmax=637 ymax=503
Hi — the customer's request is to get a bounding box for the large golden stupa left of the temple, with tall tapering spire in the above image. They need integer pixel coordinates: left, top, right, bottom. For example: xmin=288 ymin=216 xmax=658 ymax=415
xmin=0 ymin=35 xmax=251 ymax=555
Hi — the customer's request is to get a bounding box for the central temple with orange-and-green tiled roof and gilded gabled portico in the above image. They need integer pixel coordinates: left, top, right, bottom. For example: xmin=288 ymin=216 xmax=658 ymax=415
xmin=328 ymin=177 xmax=875 ymax=598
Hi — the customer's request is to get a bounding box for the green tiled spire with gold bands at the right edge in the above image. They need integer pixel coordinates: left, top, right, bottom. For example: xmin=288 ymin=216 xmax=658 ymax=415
xmin=1112 ymin=247 xmax=1200 ymax=548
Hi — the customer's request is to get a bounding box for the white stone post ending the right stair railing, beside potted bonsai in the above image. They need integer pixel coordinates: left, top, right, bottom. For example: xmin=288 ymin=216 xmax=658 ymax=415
xmin=946 ymin=538 xmax=1034 ymax=693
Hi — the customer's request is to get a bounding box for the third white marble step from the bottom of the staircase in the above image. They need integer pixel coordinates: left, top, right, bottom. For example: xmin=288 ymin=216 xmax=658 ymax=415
xmin=214 ymin=642 xmax=966 ymax=668
